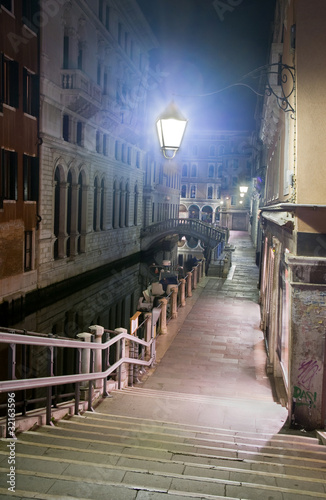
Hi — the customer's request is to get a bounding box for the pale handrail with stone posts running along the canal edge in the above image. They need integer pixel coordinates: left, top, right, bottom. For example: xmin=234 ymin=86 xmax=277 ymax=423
xmin=0 ymin=261 xmax=204 ymax=437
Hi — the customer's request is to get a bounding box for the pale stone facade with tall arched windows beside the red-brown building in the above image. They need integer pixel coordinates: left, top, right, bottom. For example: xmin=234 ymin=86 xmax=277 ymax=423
xmin=38 ymin=0 xmax=156 ymax=287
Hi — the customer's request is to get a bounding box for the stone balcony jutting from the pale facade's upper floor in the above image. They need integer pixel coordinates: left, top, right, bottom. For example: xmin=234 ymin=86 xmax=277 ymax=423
xmin=61 ymin=69 xmax=102 ymax=119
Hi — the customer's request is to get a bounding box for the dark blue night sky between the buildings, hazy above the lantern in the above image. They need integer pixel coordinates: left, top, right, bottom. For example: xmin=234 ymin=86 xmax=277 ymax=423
xmin=138 ymin=0 xmax=275 ymax=130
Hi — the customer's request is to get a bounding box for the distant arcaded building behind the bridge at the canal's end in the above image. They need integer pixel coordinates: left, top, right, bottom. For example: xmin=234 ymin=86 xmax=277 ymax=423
xmin=178 ymin=130 xmax=251 ymax=265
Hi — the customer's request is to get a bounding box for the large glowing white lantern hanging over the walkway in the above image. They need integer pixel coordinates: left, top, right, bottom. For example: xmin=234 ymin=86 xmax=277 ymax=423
xmin=156 ymin=102 xmax=187 ymax=160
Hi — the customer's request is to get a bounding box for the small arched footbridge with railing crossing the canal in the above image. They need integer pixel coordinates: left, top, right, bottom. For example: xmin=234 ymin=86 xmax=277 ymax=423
xmin=141 ymin=219 xmax=229 ymax=251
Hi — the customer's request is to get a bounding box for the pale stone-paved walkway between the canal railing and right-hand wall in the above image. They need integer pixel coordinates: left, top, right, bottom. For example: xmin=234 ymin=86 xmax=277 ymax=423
xmin=99 ymin=232 xmax=287 ymax=433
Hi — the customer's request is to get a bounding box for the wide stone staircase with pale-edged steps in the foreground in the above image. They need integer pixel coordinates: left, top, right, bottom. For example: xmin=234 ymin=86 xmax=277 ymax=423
xmin=0 ymin=389 xmax=326 ymax=500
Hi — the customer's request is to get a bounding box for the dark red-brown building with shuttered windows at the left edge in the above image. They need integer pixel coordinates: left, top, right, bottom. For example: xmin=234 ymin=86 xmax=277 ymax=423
xmin=0 ymin=0 xmax=40 ymax=310
